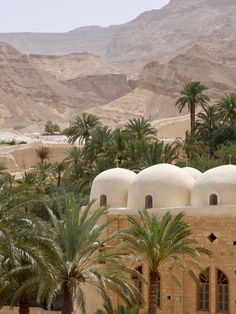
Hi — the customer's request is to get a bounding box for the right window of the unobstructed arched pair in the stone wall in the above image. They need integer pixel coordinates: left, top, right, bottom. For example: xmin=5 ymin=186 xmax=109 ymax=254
xmin=217 ymin=269 xmax=229 ymax=313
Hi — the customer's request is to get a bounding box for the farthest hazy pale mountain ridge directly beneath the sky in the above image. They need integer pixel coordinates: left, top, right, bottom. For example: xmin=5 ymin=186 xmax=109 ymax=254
xmin=0 ymin=0 xmax=236 ymax=68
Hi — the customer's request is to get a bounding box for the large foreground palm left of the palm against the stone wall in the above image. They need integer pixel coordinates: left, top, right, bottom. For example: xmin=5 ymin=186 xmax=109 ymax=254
xmin=39 ymin=195 xmax=136 ymax=314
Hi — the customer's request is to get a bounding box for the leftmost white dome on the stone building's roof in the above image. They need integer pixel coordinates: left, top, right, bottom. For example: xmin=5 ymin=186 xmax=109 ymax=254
xmin=90 ymin=168 xmax=136 ymax=208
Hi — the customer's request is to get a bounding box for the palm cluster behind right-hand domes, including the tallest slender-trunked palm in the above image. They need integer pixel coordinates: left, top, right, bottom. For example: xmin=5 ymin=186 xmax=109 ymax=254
xmin=176 ymin=82 xmax=236 ymax=171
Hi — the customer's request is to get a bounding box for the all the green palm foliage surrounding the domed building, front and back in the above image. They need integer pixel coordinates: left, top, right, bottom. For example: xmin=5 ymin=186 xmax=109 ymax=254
xmin=0 ymin=82 xmax=236 ymax=314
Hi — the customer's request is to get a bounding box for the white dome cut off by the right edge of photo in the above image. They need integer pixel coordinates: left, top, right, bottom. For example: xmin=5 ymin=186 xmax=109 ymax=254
xmin=191 ymin=165 xmax=236 ymax=206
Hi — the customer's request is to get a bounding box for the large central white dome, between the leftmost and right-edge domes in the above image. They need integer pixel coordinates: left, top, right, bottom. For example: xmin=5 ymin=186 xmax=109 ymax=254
xmin=128 ymin=164 xmax=194 ymax=209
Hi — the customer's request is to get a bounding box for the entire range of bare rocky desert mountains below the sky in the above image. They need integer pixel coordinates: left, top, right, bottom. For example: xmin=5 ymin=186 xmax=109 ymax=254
xmin=0 ymin=0 xmax=236 ymax=134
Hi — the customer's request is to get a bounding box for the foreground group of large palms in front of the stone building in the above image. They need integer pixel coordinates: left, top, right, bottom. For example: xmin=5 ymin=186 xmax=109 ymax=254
xmin=0 ymin=169 xmax=209 ymax=314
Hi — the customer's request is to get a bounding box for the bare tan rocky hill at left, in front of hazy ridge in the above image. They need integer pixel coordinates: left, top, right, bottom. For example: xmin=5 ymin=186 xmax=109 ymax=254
xmin=0 ymin=43 xmax=129 ymax=130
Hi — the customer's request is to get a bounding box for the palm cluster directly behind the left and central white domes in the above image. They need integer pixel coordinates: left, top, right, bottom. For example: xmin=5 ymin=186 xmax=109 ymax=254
xmin=64 ymin=114 xmax=177 ymax=193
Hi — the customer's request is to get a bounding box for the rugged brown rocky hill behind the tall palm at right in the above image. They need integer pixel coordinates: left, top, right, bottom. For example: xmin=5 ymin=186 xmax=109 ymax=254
xmin=86 ymin=45 xmax=236 ymax=127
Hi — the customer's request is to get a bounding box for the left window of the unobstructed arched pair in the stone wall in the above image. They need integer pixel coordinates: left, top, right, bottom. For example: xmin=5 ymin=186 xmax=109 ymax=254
xmin=198 ymin=270 xmax=209 ymax=311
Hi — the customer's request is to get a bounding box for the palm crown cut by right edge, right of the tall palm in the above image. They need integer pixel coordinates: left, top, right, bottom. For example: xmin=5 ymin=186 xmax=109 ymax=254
xmin=216 ymin=93 xmax=236 ymax=125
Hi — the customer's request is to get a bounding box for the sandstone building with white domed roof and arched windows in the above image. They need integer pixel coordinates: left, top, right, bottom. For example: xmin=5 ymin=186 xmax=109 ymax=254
xmin=90 ymin=164 xmax=236 ymax=314
